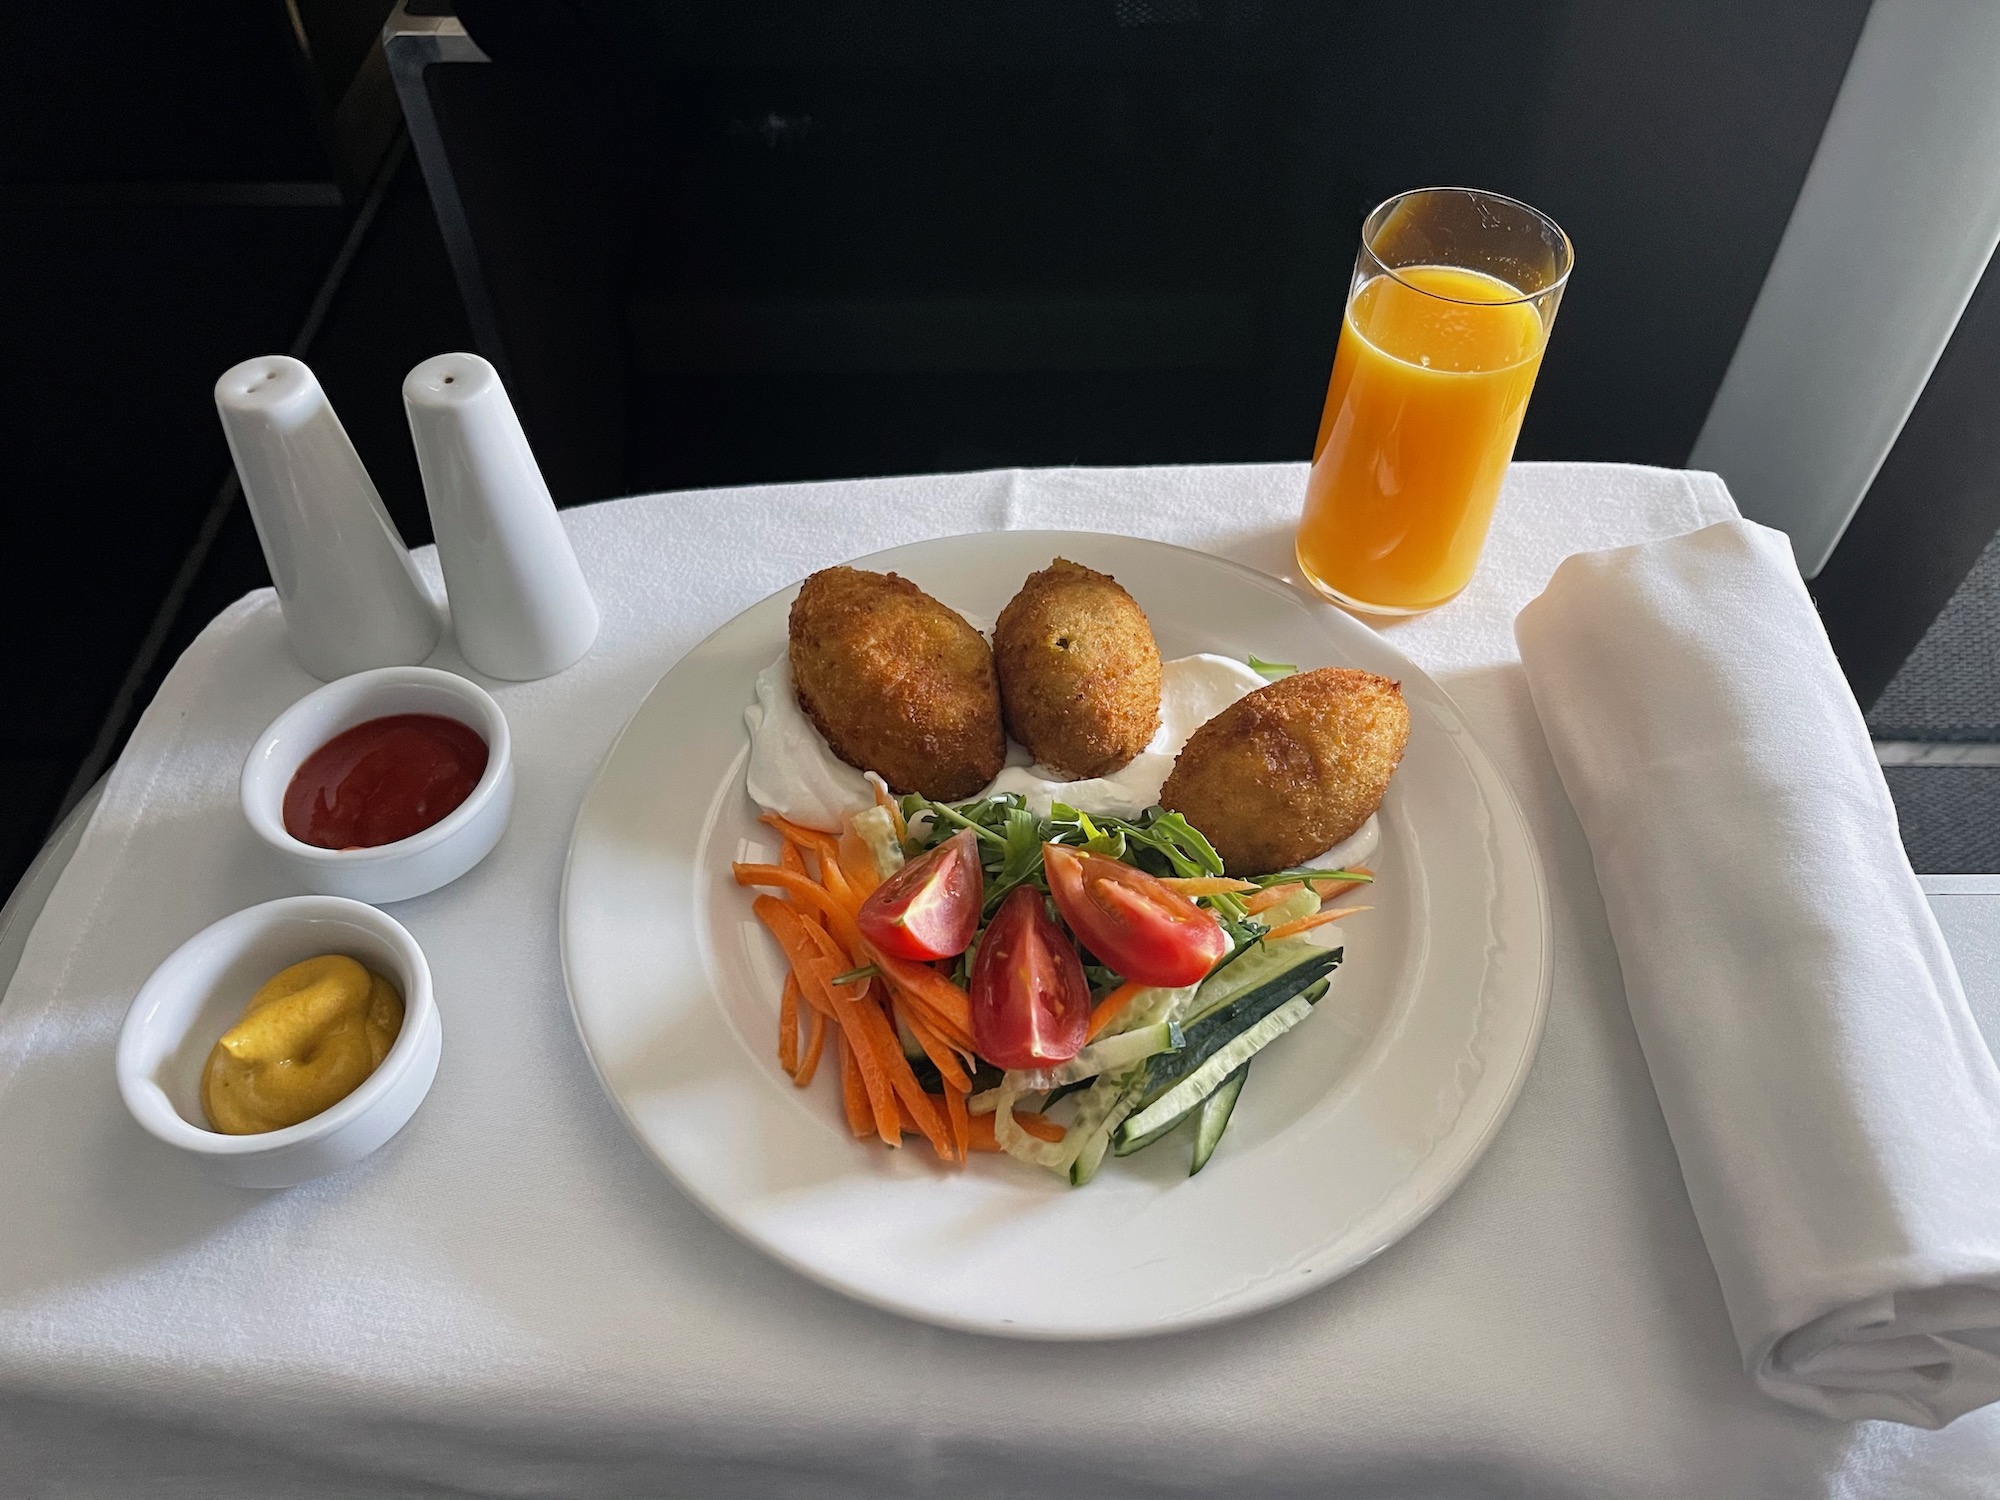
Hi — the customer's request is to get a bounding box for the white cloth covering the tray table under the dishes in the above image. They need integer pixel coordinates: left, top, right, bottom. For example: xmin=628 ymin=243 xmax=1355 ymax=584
xmin=0 ymin=464 xmax=2000 ymax=1500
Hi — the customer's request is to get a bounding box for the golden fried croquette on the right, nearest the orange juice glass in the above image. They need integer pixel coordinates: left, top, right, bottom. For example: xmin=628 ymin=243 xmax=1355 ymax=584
xmin=1160 ymin=666 xmax=1410 ymax=876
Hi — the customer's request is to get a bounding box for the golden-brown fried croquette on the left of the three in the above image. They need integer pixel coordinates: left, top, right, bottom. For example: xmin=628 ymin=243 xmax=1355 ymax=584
xmin=790 ymin=568 xmax=1006 ymax=802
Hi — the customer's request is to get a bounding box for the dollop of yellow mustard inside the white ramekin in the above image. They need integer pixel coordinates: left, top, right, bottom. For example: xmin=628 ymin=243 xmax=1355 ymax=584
xmin=202 ymin=954 xmax=402 ymax=1136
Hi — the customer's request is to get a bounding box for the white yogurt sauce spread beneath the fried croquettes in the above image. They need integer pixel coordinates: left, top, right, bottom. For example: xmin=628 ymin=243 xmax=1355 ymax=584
xmin=744 ymin=652 xmax=1380 ymax=868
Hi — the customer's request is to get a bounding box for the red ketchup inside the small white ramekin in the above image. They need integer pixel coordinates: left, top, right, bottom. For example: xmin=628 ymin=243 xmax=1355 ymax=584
xmin=284 ymin=714 xmax=486 ymax=848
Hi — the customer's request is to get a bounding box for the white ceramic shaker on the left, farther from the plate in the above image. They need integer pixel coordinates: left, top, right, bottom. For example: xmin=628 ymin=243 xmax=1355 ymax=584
xmin=216 ymin=354 xmax=442 ymax=682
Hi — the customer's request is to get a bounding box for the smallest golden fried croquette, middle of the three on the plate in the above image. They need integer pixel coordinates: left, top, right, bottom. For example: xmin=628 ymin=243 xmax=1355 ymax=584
xmin=994 ymin=558 xmax=1160 ymax=778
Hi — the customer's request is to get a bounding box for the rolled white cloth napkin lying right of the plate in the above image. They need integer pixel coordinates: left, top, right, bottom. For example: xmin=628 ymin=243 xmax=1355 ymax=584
xmin=1514 ymin=520 xmax=2000 ymax=1428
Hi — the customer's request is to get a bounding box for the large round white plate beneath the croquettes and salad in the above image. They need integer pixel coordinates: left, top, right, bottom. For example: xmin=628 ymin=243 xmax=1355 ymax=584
xmin=562 ymin=532 xmax=1550 ymax=1338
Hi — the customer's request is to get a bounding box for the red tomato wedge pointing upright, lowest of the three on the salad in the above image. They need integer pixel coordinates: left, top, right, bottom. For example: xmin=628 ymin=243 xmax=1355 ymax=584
xmin=972 ymin=886 xmax=1090 ymax=1068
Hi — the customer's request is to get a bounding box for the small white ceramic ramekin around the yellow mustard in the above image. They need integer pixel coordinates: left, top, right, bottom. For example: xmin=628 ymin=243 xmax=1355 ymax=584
xmin=118 ymin=896 xmax=444 ymax=1188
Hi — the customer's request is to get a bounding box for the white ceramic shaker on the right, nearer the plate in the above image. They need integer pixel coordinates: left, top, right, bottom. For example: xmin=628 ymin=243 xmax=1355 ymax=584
xmin=402 ymin=354 xmax=598 ymax=682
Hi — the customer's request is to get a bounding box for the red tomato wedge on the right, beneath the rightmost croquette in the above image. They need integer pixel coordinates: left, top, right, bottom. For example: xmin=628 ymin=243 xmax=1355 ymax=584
xmin=1042 ymin=844 xmax=1230 ymax=986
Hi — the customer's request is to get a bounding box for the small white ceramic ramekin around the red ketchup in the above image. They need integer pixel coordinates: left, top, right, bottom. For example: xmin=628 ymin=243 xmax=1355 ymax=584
xmin=242 ymin=666 xmax=514 ymax=904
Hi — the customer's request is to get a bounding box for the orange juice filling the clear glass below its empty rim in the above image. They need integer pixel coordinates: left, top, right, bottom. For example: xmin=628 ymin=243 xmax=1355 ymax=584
xmin=1298 ymin=266 xmax=1552 ymax=614
